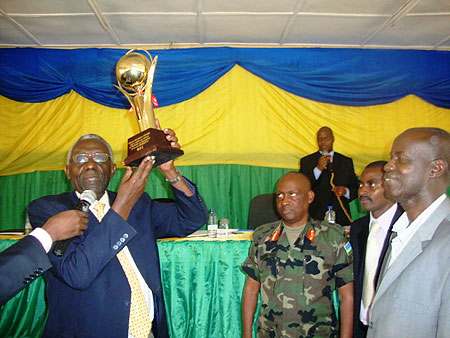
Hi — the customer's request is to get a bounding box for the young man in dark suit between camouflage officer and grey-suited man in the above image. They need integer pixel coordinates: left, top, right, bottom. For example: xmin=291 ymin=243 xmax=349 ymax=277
xmin=350 ymin=161 xmax=403 ymax=338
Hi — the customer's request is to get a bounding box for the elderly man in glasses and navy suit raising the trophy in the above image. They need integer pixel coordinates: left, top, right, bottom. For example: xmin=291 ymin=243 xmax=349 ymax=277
xmin=28 ymin=129 xmax=207 ymax=338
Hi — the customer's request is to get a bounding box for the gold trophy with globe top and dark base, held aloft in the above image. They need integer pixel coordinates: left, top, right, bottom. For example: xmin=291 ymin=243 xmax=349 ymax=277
xmin=115 ymin=49 xmax=184 ymax=167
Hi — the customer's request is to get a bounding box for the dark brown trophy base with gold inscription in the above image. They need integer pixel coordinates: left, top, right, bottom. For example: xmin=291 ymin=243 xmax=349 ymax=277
xmin=123 ymin=128 xmax=184 ymax=167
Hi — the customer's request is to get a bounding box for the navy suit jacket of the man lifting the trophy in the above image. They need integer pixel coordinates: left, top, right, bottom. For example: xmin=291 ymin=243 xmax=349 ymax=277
xmin=28 ymin=184 xmax=207 ymax=338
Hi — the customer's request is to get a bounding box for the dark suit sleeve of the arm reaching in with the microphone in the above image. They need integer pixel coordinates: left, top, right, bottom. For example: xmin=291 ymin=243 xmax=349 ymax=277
xmin=0 ymin=236 xmax=52 ymax=305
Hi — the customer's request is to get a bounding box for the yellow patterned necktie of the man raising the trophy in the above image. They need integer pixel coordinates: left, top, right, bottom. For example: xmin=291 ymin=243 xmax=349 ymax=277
xmin=93 ymin=202 xmax=152 ymax=338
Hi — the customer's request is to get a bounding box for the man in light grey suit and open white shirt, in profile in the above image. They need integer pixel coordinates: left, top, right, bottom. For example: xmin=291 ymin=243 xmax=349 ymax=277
xmin=367 ymin=128 xmax=450 ymax=338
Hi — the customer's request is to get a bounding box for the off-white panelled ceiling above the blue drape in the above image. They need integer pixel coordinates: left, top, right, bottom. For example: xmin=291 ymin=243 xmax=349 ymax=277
xmin=0 ymin=0 xmax=450 ymax=50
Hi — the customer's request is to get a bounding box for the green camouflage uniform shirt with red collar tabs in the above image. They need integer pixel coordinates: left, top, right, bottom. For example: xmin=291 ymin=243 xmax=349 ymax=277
xmin=242 ymin=221 xmax=353 ymax=338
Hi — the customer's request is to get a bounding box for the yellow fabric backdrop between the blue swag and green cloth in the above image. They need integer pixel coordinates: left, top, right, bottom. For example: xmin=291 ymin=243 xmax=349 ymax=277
xmin=0 ymin=66 xmax=450 ymax=175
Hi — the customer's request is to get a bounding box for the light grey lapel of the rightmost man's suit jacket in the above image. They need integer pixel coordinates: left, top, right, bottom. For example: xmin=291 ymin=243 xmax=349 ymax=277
xmin=374 ymin=198 xmax=450 ymax=302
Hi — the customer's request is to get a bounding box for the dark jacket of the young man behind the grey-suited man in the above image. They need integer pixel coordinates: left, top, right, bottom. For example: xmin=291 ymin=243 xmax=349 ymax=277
xmin=350 ymin=204 xmax=403 ymax=338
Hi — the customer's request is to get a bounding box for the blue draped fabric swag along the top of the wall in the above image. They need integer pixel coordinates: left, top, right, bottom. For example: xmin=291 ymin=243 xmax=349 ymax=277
xmin=0 ymin=47 xmax=450 ymax=109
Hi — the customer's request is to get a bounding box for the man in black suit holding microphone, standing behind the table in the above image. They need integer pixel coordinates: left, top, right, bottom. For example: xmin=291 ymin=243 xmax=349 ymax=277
xmin=300 ymin=127 xmax=358 ymax=225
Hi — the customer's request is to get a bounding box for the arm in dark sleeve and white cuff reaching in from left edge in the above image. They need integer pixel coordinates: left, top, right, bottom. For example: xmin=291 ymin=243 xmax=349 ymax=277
xmin=0 ymin=210 xmax=87 ymax=305
